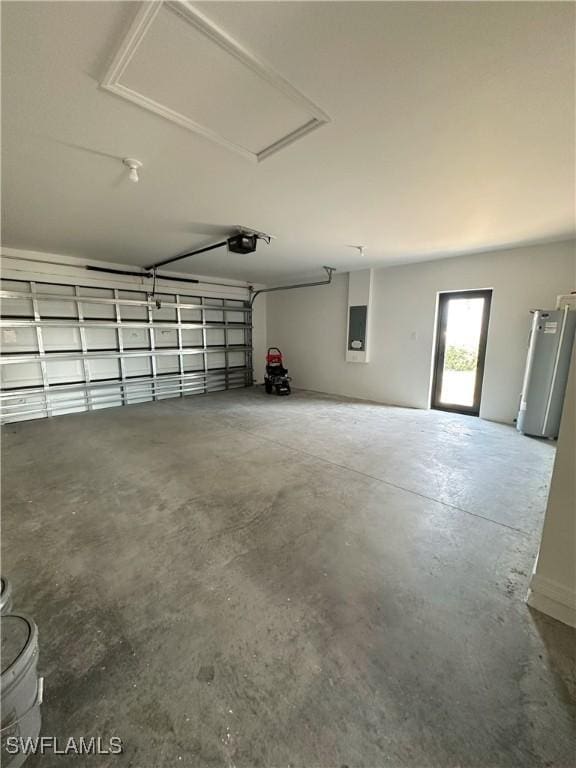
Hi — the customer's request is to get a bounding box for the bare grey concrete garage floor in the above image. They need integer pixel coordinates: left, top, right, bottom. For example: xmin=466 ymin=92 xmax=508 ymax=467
xmin=3 ymin=388 xmax=576 ymax=768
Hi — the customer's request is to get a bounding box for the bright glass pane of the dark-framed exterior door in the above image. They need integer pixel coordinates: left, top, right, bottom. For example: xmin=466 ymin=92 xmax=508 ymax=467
xmin=440 ymin=298 xmax=484 ymax=406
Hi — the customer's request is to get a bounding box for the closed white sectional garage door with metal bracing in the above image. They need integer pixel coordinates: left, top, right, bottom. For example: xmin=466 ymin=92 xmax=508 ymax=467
xmin=0 ymin=280 xmax=252 ymax=422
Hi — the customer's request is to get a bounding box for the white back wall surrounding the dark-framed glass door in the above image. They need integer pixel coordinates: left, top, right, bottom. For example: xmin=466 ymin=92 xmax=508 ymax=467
xmin=267 ymin=241 xmax=576 ymax=422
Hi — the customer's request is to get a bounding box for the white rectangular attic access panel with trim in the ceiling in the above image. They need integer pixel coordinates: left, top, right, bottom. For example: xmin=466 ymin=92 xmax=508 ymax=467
xmin=101 ymin=0 xmax=329 ymax=161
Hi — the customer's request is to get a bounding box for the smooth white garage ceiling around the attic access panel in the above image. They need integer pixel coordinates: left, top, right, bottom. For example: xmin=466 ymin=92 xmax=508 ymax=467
xmin=2 ymin=2 xmax=575 ymax=281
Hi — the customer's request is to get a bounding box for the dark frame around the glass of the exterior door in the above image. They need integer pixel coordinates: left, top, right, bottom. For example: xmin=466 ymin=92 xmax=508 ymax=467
xmin=430 ymin=288 xmax=492 ymax=416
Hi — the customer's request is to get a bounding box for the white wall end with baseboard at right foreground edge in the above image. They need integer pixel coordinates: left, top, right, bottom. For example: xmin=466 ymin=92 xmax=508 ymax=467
xmin=528 ymin=349 xmax=576 ymax=627
